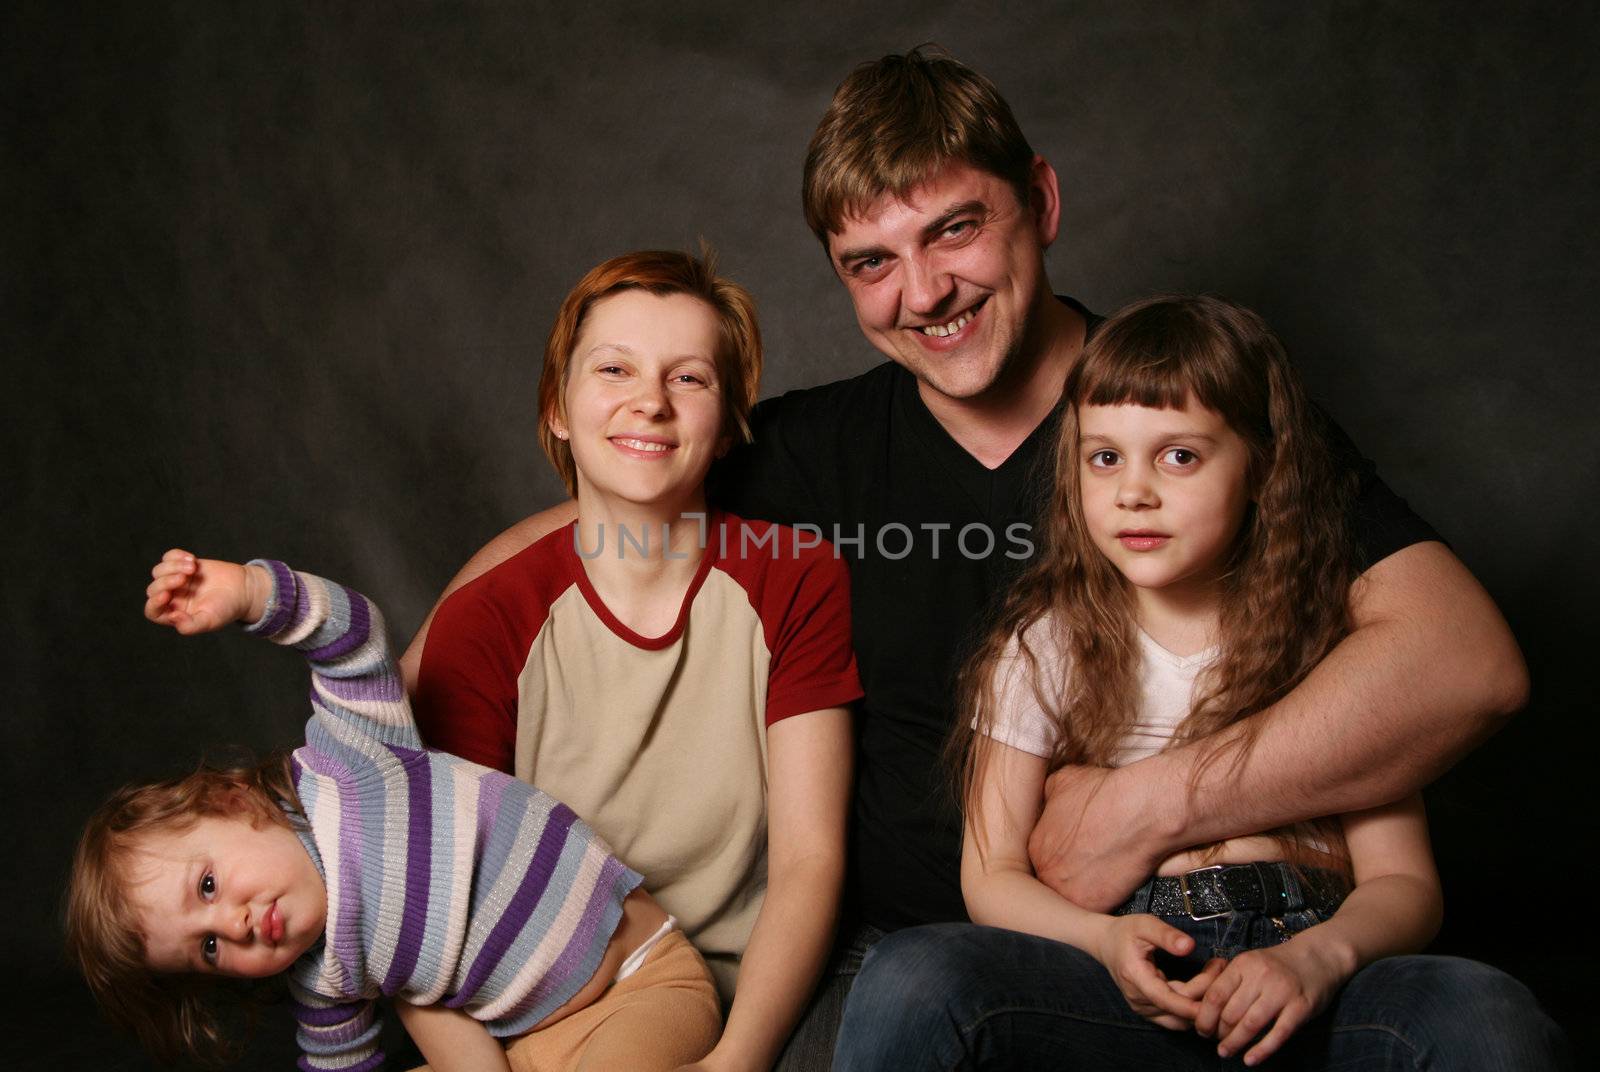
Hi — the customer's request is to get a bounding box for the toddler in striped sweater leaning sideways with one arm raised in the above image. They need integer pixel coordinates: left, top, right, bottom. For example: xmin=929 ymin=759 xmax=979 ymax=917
xmin=67 ymin=550 xmax=720 ymax=1072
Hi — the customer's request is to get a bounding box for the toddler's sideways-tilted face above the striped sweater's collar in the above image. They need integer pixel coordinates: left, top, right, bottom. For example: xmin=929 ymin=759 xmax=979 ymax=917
xmin=128 ymin=816 xmax=328 ymax=978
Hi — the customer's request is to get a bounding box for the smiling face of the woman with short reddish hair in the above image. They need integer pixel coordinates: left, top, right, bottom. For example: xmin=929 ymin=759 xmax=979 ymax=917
xmin=550 ymin=290 xmax=728 ymax=512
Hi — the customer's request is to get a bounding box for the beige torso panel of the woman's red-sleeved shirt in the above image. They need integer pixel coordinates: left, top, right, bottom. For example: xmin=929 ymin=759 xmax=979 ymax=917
xmin=515 ymin=570 xmax=771 ymax=1000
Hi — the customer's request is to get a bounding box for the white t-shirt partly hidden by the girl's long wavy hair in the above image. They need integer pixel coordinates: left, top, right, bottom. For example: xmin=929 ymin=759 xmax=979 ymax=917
xmin=989 ymin=618 xmax=1218 ymax=766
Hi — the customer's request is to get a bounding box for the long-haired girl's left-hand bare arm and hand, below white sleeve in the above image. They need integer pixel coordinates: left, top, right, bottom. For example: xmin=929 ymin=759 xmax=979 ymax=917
xmin=962 ymin=741 xmax=1198 ymax=1029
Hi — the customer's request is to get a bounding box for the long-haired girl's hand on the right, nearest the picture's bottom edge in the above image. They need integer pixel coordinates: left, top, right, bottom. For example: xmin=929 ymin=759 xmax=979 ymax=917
xmin=1195 ymin=939 xmax=1350 ymax=1066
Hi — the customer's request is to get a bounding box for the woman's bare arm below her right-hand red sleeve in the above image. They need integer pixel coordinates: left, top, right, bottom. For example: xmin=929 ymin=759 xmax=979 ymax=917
xmin=696 ymin=707 xmax=853 ymax=1070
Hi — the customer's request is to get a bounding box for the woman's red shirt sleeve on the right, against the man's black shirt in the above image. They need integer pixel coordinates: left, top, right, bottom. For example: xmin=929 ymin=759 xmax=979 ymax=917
xmin=752 ymin=523 xmax=861 ymax=726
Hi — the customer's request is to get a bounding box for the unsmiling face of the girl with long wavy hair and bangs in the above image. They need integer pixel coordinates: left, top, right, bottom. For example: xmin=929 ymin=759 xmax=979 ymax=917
xmin=1078 ymin=395 xmax=1251 ymax=604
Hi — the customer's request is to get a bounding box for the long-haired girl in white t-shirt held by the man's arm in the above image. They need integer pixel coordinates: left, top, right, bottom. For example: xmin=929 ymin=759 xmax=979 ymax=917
xmin=958 ymin=298 xmax=1442 ymax=1064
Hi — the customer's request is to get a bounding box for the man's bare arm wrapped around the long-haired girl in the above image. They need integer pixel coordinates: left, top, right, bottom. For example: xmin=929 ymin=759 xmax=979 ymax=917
xmin=1029 ymin=541 xmax=1528 ymax=910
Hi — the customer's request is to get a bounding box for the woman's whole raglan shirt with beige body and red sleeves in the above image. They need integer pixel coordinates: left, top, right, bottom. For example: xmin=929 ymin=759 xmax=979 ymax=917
xmin=416 ymin=512 xmax=861 ymax=998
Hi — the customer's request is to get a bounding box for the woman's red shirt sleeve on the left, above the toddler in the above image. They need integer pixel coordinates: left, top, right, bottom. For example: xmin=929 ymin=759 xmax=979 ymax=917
xmin=413 ymin=560 xmax=549 ymax=774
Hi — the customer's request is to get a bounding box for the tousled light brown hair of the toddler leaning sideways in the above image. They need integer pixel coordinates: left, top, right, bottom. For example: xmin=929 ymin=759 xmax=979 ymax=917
xmin=66 ymin=752 xmax=304 ymax=1066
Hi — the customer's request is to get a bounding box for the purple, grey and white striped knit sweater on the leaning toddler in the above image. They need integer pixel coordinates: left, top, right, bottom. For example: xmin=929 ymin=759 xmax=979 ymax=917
xmin=246 ymin=562 xmax=640 ymax=1072
